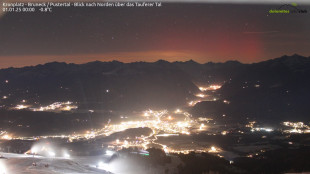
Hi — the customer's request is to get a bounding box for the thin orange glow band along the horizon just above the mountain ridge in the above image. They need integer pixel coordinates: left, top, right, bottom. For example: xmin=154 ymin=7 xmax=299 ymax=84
xmin=0 ymin=51 xmax=272 ymax=68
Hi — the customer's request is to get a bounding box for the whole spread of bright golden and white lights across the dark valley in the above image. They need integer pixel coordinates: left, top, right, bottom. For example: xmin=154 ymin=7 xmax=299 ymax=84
xmin=0 ymin=80 xmax=310 ymax=172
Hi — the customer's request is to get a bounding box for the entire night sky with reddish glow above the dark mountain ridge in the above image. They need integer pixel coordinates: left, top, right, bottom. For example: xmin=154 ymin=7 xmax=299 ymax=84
xmin=0 ymin=3 xmax=310 ymax=68
